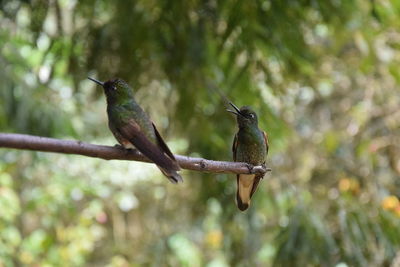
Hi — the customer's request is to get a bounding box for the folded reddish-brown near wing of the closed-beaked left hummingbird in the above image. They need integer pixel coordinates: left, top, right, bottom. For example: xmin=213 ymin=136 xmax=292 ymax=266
xmin=117 ymin=119 xmax=179 ymax=171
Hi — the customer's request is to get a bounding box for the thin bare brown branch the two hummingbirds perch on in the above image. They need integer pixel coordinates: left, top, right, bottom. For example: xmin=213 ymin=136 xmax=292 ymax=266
xmin=0 ymin=133 xmax=271 ymax=174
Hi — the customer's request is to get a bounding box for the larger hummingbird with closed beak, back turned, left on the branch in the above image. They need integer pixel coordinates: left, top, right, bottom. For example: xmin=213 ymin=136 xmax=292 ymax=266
xmin=88 ymin=77 xmax=183 ymax=184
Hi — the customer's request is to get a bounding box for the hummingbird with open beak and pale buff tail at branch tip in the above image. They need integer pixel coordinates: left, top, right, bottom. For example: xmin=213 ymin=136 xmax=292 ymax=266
xmin=227 ymin=102 xmax=268 ymax=211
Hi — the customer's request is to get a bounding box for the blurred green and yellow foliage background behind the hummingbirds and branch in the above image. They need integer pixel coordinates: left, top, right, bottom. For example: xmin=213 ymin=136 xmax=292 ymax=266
xmin=0 ymin=0 xmax=400 ymax=266
